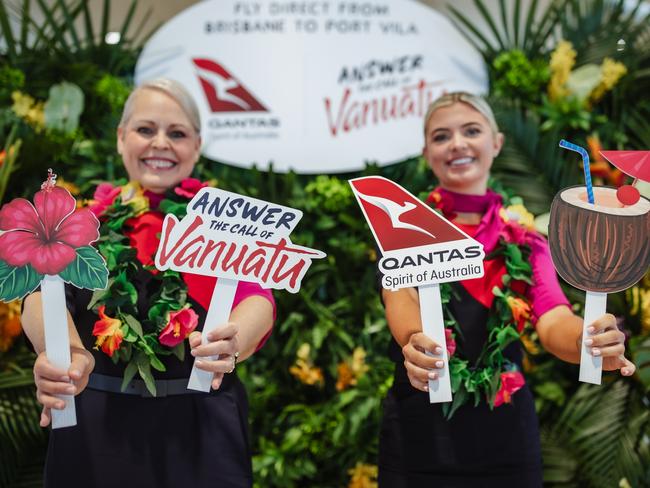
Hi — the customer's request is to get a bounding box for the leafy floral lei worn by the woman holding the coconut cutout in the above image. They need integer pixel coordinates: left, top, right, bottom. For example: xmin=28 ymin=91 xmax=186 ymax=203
xmin=427 ymin=190 xmax=533 ymax=418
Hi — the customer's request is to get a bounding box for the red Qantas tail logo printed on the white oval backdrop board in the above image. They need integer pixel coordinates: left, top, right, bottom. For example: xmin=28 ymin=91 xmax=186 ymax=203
xmin=192 ymin=58 xmax=268 ymax=112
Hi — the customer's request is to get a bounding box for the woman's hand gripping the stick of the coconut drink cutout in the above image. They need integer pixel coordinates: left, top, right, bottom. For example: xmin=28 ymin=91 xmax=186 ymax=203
xmin=578 ymin=313 xmax=636 ymax=376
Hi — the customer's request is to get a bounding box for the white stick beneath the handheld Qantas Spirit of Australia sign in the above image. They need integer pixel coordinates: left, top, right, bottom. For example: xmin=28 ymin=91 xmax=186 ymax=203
xmin=418 ymin=284 xmax=451 ymax=403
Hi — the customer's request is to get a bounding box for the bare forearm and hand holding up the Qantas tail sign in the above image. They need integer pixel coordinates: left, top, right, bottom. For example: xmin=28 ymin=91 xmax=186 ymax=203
xmin=382 ymin=288 xmax=444 ymax=391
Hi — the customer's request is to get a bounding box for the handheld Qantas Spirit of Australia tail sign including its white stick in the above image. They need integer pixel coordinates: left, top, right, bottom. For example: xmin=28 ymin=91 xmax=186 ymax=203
xmin=350 ymin=176 xmax=485 ymax=403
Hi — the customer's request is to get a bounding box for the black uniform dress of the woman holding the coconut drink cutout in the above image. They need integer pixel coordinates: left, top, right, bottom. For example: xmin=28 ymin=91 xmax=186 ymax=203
xmin=379 ymin=284 xmax=542 ymax=488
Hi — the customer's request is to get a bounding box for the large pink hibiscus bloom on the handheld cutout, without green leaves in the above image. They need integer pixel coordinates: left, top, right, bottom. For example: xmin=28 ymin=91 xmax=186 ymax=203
xmin=0 ymin=187 xmax=99 ymax=275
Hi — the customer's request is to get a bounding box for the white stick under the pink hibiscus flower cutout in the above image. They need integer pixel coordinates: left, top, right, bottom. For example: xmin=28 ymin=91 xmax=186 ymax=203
xmin=41 ymin=275 xmax=77 ymax=429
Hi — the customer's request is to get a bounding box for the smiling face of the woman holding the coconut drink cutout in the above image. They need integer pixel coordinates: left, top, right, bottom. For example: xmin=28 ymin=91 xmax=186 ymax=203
xmin=423 ymin=102 xmax=503 ymax=195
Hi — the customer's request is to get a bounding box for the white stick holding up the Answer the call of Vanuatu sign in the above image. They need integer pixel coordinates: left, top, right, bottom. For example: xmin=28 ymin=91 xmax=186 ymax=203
xmin=187 ymin=278 xmax=239 ymax=392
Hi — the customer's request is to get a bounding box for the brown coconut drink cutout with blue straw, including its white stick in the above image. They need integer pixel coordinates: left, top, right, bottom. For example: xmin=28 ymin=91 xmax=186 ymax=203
xmin=548 ymin=140 xmax=650 ymax=385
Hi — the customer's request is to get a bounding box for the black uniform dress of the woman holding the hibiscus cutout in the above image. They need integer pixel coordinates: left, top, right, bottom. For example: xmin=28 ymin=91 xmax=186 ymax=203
xmin=45 ymin=272 xmax=252 ymax=488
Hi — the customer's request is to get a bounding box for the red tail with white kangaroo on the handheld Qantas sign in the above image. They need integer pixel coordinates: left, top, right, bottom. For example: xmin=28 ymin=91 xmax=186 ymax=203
xmin=350 ymin=176 xmax=468 ymax=252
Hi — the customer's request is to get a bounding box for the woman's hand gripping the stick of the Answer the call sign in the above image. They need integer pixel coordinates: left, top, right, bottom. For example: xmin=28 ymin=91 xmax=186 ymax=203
xmin=190 ymin=322 xmax=239 ymax=390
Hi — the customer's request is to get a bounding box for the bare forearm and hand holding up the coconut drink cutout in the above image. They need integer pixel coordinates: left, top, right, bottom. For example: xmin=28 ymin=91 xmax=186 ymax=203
xmin=536 ymin=305 xmax=636 ymax=376
